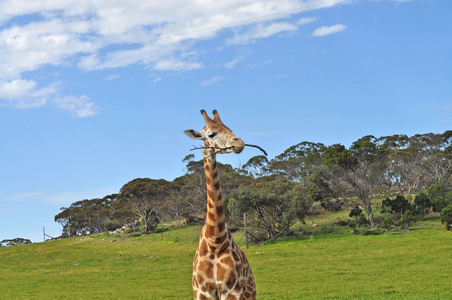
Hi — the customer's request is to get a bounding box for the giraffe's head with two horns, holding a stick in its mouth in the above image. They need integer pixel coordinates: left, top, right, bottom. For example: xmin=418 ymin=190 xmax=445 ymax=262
xmin=184 ymin=110 xmax=245 ymax=154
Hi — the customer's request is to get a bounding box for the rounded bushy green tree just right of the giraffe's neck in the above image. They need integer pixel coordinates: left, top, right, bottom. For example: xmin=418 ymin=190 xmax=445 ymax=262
xmin=229 ymin=179 xmax=312 ymax=240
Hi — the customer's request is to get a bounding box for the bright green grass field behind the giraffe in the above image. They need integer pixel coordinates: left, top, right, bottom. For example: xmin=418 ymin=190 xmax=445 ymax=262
xmin=0 ymin=216 xmax=452 ymax=300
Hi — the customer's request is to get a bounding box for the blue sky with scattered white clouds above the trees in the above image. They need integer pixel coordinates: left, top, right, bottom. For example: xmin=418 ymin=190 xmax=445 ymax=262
xmin=0 ymin=0 xmax=452 ymax=242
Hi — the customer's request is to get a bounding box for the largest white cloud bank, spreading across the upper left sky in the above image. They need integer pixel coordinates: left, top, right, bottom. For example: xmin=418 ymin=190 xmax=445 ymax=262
xmin=0 ymin=0 xmax=347 ymax=117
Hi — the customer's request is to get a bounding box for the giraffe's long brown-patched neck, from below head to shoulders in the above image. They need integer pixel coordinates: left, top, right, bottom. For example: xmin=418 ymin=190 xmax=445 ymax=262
xmin=204 ymin=153 xmax=226 ymax=244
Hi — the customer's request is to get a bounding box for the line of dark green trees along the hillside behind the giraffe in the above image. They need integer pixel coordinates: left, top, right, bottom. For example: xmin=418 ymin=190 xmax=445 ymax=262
xmin=55 ymin=131 xmax=452 ymax=240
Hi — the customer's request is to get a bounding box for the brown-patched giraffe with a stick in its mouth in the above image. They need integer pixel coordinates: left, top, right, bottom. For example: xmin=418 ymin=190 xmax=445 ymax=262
xmin=184 ymin=110 xmax=256 ymax=300
